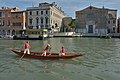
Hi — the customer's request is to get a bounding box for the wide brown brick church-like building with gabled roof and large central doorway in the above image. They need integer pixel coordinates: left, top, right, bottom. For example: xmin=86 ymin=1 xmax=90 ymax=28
xmin=76 ymin=6 xmax=117 ymax=35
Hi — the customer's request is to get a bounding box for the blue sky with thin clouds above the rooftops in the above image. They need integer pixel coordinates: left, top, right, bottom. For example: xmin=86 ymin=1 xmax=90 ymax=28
xmin=0 ymin=0 xmax=120 ymax=19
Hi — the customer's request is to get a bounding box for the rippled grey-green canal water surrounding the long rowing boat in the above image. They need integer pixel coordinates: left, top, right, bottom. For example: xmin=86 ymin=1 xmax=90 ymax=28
xmin=0 ymin=38 xmax=120 ymax=80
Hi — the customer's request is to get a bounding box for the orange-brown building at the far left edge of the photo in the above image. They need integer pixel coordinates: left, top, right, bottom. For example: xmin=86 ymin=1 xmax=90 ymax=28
xmin=0 ymin=7 xmax=19 ymax=35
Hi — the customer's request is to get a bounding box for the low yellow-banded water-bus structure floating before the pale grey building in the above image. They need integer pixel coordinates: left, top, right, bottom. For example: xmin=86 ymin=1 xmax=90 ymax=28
xmin=13 ymin=29 xmax=48 ymax=40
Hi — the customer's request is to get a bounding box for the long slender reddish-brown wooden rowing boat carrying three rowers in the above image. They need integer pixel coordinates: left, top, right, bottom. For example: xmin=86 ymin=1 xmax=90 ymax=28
xmin=11 ymin=49 xmax=82 ymax=60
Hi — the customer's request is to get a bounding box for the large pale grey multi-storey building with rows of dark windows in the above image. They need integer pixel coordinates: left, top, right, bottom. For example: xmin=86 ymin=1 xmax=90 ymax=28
xmin=26 ymin=2 xmax=64 ymax=31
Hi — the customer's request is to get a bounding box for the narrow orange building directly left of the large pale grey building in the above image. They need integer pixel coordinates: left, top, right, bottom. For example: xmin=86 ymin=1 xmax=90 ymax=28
xmin=10 ymin=11 xmax=26 ymax=35
